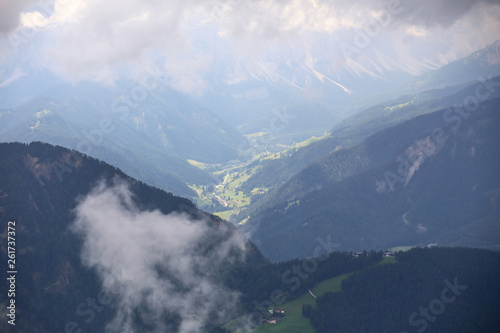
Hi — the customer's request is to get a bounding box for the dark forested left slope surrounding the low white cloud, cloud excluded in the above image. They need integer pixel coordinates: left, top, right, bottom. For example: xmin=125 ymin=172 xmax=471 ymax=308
xmin=0 ymin=143 xmax=272 ymax=333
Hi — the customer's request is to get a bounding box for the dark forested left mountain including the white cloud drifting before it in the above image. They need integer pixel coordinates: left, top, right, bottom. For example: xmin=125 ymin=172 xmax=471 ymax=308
xmin=0 ymin=143 xmax=273 ymax=333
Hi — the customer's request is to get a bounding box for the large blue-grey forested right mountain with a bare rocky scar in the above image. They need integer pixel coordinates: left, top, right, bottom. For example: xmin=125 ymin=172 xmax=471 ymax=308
xmin=240 ymin=92 xmax=500 ymax=261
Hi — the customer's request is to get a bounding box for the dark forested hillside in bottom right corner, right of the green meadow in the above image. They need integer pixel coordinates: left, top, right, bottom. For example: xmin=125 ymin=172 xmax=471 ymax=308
xmin=306 ymin=248 xmax=500 ymax=333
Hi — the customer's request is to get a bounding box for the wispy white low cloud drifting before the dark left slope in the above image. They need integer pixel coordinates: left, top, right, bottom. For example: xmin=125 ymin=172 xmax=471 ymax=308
xmin=72 ymin=182 xmax=246 ymax=333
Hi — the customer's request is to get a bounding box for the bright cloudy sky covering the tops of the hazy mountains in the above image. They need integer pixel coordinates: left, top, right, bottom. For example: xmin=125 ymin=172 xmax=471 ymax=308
xmin=0 ymin=0 xmax=500 ymax=93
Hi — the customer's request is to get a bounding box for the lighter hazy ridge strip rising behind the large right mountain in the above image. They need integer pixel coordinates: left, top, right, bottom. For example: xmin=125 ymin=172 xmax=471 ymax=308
xmin=237 ymin=77 xmax=500 ymax=205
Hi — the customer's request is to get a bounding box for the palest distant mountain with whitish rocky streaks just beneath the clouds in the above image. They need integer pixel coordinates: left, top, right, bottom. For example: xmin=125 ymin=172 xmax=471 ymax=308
xmin=193 ymin=51 xmax=414 ymax=144
